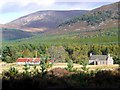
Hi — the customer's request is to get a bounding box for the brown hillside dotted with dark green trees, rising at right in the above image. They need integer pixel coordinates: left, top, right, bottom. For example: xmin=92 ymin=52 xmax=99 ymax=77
xmin=57 ymin=2 xmax=120 ymax=33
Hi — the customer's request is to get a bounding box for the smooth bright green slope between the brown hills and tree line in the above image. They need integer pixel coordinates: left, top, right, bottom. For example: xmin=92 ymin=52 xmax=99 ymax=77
xmin=3 ymin=27 xmax=119 ymax=46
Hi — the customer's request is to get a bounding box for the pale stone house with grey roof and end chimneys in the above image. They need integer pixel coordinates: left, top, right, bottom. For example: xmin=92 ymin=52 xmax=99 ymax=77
xmin=89 ymin=53 xmax=113 ymax=65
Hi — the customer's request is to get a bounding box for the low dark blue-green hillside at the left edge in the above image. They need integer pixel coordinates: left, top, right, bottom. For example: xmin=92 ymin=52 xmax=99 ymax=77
xmin=0 ymin=24 xmax=34 ymax=41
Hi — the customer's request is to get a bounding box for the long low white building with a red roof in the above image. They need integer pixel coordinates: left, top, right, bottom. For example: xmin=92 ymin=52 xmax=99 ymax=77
xmin=16 ymin=58 xmax=40 ymax=65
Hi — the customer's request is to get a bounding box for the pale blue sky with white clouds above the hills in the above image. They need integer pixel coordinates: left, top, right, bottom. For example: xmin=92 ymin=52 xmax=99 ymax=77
xmin=0 ymin=0 xmax=119 ymax=24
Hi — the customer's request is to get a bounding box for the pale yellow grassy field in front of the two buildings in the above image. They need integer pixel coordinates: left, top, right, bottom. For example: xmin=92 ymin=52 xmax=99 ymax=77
xmin=0 ymin=62 xmax=119 ymax=73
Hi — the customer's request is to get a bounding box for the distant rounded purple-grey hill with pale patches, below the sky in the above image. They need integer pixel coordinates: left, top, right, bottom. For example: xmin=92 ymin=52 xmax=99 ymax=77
xmin=6 ymin=10 xmax=87 ymax=32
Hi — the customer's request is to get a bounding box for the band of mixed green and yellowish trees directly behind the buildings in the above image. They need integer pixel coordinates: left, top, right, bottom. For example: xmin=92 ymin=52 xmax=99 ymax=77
xmin=1 ymin=44 xmax=120 ymax=64
